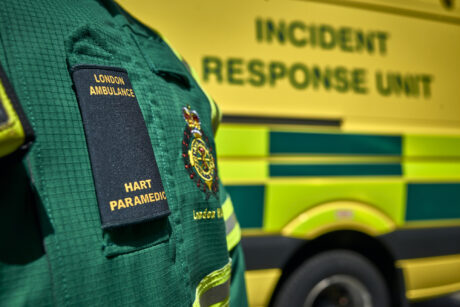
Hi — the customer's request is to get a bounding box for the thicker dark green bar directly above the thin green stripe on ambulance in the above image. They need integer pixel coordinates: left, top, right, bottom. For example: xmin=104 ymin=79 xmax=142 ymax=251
xmin=270 ymin=131 xmax=402 ymax=155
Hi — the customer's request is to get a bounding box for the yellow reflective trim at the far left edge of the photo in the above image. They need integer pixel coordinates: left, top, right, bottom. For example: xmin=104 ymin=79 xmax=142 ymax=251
xmin=0 ymin=81 xmax=25 ymax=157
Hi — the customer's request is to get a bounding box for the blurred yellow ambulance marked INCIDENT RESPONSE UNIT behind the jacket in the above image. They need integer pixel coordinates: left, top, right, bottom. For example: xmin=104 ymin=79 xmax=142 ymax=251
xmin=119 ymin=0 xmax=460 ymax=307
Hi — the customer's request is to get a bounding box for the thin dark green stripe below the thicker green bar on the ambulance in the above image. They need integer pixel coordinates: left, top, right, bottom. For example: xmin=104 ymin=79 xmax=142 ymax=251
xmin=270 ymin=163 xmax=402 ymax=177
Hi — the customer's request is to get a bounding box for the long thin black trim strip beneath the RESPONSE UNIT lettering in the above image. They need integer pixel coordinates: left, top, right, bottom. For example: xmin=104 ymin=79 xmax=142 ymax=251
xmin=222 ymin=114 xmax=342 ymax=128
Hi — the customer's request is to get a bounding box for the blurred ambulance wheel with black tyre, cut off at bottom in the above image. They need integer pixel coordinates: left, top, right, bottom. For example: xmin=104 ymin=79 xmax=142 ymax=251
xmin=273 ymin=250 xmax=390 ymax=307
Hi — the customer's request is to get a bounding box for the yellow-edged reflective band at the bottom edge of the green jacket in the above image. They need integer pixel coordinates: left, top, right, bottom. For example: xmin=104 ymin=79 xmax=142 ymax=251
xmin=193 ymin=259 xmax=232 ymax=307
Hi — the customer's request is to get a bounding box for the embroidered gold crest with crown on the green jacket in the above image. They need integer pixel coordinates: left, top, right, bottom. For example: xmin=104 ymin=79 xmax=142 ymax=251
xmin=182 ymin=106 xmax=219 ymax=198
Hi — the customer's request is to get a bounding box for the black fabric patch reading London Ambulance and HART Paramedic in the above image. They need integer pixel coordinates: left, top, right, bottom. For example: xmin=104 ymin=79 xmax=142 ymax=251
xmin=72 ymin=65 xmax=170 ymax=228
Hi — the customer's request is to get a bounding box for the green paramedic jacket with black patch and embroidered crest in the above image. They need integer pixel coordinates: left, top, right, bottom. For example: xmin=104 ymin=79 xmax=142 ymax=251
xmin=0 ymin=0 xmax=247 ymax=306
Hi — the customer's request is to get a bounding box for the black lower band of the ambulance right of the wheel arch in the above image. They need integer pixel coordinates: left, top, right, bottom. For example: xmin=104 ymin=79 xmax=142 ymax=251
xmin=379 ymin=227 xmax=460 ymax=260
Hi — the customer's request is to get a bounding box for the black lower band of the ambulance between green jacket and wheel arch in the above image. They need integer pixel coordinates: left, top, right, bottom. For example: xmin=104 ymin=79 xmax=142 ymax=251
xmin=241 ymin=236 xmax=306 ymax=270
